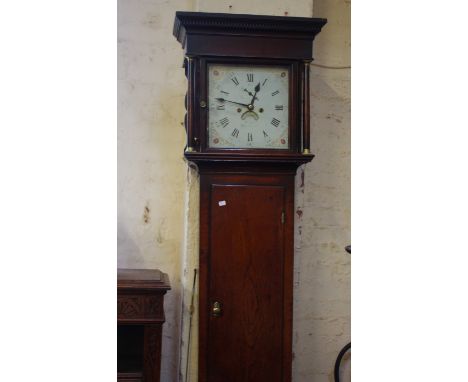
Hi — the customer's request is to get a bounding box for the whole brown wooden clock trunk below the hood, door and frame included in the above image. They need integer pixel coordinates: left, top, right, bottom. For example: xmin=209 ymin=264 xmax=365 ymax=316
xmin=199 ymin=166 xmax=295 ymax=382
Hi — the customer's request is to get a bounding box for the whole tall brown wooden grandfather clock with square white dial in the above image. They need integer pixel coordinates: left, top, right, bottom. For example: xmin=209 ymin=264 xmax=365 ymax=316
xmin=174 ymin=12 xmax=326 ymax=382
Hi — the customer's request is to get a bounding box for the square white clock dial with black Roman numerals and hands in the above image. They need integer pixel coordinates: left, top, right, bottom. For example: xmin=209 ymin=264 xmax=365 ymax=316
xmin=208 ymin=64 xmax=289 ymax=149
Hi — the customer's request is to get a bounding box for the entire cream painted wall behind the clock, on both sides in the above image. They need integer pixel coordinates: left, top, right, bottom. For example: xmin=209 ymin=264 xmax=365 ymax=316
xmin=118 ymin=0 xmax=350 ymax=382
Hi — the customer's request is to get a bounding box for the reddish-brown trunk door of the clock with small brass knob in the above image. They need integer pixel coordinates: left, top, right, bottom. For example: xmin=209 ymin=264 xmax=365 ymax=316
xmin=207 ymin=185 xmax=285 ymax=382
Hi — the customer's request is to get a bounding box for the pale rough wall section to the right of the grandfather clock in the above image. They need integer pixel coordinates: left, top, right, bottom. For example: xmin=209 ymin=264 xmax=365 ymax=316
xmin=293 ymin=0 xmax=351 ymax=382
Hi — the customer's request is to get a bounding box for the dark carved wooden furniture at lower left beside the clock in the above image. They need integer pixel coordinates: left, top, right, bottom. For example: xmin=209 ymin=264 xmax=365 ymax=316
xmin=117 ymin=269 xmax=170 ymax=382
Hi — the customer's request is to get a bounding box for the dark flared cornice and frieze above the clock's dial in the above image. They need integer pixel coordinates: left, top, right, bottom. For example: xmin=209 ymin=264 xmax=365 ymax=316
xmin=173 ymin=12 xmax=327 ymax=60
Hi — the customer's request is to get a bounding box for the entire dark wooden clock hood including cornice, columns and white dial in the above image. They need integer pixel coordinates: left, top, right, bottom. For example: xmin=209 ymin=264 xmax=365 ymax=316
xmin=173 ymin=12 xmax=327 ymax=166
